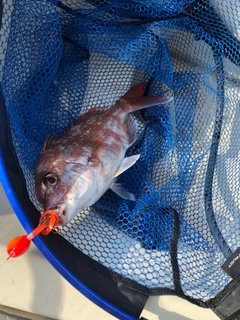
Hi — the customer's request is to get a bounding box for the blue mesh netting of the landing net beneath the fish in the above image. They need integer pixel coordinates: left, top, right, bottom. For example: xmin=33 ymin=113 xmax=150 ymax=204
xmin=0 ymin=0 xmax=240 ymax=301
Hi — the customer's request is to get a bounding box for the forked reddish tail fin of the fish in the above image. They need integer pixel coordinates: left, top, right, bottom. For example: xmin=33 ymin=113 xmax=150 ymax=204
xmin=118 ymin=82 xmax=173 ymax=112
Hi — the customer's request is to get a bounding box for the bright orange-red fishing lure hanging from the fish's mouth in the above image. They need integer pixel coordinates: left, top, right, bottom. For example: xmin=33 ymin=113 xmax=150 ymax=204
xmin=7 ymin=210 xmax=59 ymax=260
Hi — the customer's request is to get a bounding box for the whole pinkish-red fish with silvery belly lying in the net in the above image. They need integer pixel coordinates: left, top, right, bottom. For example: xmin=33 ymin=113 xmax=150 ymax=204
xmin=35 ymin=83 xmax=172 ymax=225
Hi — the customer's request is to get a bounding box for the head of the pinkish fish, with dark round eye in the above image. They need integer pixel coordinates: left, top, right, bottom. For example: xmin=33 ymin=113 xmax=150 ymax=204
xmin=34 ymin=150 xmax=94 ymax=226
